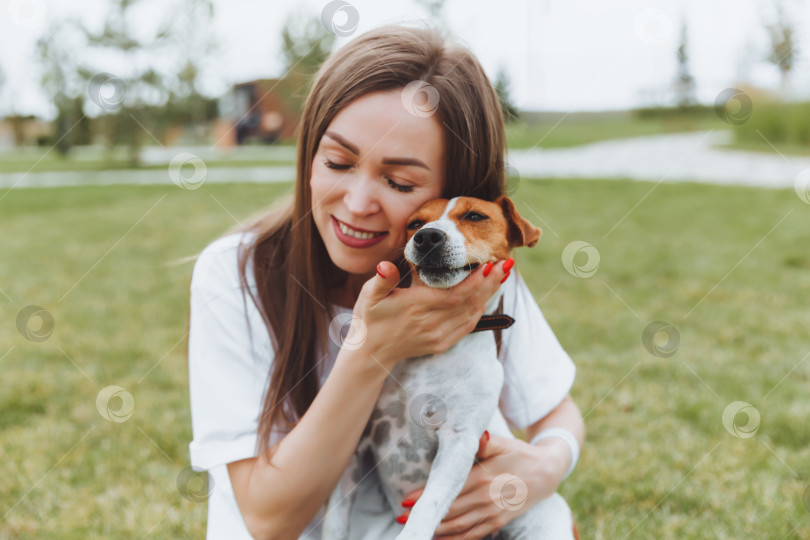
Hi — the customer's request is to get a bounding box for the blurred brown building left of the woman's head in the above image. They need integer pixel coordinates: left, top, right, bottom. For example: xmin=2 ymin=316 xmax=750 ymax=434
xmin=217 ymin=79 xmax=298 ymax=146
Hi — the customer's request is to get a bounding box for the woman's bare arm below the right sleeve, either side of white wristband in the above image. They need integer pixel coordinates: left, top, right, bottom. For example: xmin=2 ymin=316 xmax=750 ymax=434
xmin=526 ymin=394 xmax=585 ymax=495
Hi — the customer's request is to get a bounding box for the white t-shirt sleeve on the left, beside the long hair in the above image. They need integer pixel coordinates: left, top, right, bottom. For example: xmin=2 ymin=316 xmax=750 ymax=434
xmin=188 ymin=237 xmax=283 ymax=469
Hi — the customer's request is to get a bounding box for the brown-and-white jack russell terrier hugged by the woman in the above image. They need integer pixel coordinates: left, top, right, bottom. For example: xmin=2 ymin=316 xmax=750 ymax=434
xmin=322 ymin=197 xmax=571 ymax=540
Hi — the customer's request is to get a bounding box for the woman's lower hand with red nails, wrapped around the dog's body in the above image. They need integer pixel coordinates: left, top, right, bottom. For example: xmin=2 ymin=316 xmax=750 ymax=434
xmin=394 ymin=433 xmax=560 ymax=540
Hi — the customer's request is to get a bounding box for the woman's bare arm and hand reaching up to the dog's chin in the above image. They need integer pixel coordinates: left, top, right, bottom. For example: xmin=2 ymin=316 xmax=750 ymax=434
xmin=228 ymin=261 xmax=506 ymax=540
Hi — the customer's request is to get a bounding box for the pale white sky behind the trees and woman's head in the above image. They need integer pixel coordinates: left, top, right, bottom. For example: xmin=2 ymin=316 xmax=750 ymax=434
xmin=0 ymin=0 xmax=810 ymax=116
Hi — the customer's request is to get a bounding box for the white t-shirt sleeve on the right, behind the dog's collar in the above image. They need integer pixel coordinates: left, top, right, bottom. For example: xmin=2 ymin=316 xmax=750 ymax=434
xmin=500 ymin=270 xmax=576 ymax=429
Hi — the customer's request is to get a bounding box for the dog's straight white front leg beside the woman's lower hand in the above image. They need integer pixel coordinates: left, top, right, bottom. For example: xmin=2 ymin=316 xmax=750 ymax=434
xmin=396 ymin=424 xmax=479 ymax=540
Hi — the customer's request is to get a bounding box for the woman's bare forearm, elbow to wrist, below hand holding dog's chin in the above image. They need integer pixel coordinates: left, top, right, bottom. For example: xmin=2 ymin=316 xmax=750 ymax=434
xmin=242 ymin=350 xmax=387 ymax=539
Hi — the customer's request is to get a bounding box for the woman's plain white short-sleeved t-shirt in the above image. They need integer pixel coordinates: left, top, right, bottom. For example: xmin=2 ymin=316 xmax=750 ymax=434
xmin=188 ymin=233 xmax=576 ymax=540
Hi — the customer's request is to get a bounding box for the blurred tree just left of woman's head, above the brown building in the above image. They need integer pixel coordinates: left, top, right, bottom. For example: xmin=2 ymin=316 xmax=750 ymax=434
xmin=278 ymin=11 xmax=335 ymax=113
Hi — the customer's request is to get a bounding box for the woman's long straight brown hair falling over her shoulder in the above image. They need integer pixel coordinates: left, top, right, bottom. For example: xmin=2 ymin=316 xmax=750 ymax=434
xmin=228 ymin=26 xmax=505 ymax=458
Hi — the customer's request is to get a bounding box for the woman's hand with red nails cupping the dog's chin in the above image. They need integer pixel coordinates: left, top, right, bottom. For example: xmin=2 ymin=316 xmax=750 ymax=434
xmin=351 ymin=261 xmax=510 ymax=370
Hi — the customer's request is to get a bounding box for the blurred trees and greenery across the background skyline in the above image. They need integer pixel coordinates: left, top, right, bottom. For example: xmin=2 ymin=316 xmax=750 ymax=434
xmin=0 ymin=0 xmax=810 ymax=168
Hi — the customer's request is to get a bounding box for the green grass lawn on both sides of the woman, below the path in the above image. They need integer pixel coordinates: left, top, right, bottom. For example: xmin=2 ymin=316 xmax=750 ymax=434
xmin=0 ymin=179 xmax=810 ymax=540
